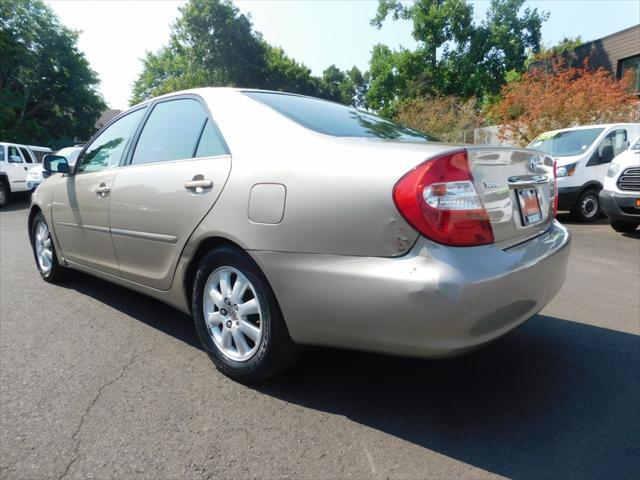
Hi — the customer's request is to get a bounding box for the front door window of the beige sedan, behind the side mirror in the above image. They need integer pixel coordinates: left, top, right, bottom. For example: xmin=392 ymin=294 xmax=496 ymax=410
xmin=76 ymin=108 xmax=146 ymax=173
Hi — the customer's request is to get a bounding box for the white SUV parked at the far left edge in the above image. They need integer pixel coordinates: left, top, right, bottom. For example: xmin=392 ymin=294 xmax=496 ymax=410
xmin=0 ymin=142 xmax=39 ymax=207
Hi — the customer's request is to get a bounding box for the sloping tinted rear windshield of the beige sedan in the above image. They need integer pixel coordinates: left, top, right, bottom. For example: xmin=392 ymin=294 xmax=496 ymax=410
xmin=243 ymin=91 xmax=435 ymax=142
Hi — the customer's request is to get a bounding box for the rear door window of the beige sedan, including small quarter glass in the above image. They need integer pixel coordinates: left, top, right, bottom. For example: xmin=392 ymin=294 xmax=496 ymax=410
xmin=131 ymin=98 xmax=226 ymax=165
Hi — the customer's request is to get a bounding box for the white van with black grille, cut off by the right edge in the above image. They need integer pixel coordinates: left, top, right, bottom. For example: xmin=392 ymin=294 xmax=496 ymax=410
xmin=600 ymin=137 xmax=640 ymax=232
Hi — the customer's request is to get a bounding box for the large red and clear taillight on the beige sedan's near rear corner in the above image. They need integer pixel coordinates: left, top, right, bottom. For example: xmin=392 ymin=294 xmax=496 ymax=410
xmin=393 ymin=150 xmax=493 ymax=247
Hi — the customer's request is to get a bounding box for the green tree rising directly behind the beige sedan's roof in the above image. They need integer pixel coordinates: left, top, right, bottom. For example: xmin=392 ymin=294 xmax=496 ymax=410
xmin=131 ymin=0 xmax=365 ymax=104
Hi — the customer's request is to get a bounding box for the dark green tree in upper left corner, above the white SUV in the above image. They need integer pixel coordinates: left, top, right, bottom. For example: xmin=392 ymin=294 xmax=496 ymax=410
xmin=0 ymin=0 xmax=106 ymax=146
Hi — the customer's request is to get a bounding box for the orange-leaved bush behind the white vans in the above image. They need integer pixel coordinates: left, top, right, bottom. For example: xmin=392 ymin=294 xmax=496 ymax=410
xmin=489 ymin=60 xmax=638 ymax=145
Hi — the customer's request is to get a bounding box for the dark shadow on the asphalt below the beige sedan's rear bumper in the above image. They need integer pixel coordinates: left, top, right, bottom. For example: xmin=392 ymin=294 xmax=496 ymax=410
xmin=257 ymin=316 xmax=640 ymax=479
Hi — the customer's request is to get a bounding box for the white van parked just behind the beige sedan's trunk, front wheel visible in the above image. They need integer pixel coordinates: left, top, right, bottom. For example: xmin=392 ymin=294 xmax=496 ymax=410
xmin=527 ymin=123 xmax=640 ymax=222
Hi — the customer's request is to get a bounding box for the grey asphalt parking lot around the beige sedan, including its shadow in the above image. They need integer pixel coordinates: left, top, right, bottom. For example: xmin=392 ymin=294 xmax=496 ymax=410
xmin=0 ymin=196 xmax=640 ymax=480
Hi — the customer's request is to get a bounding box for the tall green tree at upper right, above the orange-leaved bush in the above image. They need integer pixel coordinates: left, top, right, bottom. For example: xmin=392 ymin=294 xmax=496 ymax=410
xmin=367 ymin=0 xmax=547 ymax=115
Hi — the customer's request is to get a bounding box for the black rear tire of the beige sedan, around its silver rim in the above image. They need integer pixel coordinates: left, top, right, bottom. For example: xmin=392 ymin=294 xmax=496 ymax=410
xmin=191 ymin=247 xmax=281 ymax=382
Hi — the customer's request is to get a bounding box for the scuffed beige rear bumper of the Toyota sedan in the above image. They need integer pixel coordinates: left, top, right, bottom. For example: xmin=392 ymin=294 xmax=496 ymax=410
xmin=251 ymin=222 xmax=570 ymax=357
